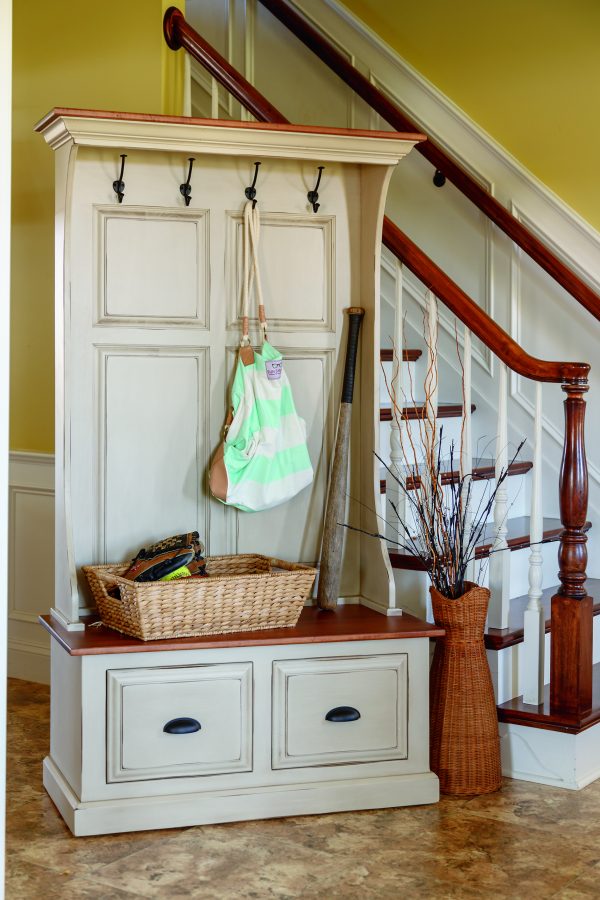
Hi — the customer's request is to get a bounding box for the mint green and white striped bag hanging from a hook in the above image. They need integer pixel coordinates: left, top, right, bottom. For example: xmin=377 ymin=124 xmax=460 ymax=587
xmin=210 ymin=201 xmax=313 ymax=512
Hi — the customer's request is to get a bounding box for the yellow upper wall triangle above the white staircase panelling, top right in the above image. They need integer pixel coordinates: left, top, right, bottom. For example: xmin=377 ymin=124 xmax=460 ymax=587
xmin=344 ymin=0 xmax=600 ymax=230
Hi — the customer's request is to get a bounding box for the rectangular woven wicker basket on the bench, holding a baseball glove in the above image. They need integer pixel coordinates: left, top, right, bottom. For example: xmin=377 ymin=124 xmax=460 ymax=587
xmin=83 ymin=554 xmax=317 ymax=641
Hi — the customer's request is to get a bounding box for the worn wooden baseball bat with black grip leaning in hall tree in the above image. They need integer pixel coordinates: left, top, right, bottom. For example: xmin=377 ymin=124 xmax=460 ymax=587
xmin=317 ymin=306 xmax=365 ymax=609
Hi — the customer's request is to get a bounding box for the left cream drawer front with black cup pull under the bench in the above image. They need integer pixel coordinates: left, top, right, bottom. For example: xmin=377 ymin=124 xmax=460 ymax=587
xmin=107 ymin=663 xmax=252 ymax=782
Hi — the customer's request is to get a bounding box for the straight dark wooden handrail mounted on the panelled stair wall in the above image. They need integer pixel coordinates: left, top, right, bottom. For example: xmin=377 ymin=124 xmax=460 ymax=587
xmin=260 ymin=0 xmax=600 ymax=319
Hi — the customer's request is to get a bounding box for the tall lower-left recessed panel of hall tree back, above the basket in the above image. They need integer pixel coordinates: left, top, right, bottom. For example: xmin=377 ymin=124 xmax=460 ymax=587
xmin=98 ymin=348 xmax=209 ymax=562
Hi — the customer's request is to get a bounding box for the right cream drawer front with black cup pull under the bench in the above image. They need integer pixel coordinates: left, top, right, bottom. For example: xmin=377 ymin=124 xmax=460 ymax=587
xmin=272 ymin=653 xmax=408 ymax=769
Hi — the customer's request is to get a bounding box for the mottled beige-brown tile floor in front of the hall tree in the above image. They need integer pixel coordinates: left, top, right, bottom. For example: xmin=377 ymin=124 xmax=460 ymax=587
xmin=7 ymin=680 xmax=600 ymax=900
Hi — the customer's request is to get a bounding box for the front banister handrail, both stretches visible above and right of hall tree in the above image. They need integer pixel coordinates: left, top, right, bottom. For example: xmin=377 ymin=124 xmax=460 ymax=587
xmin=163 ymin=6 xmax=590 ymax=382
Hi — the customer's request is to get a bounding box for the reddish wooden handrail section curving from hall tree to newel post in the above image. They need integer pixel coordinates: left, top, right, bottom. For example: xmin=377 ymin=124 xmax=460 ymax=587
xmin=383 ymin=217 xmax=590 ymax=383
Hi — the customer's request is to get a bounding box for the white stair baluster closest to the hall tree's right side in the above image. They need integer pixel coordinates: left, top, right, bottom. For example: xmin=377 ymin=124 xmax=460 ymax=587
xmin=385 ymin=260 xmax=406 ymax=541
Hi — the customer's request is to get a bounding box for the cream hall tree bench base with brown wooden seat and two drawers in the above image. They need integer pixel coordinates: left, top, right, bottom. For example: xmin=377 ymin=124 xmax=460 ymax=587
xmin=38 ymin=605 xmax=440 ymax=835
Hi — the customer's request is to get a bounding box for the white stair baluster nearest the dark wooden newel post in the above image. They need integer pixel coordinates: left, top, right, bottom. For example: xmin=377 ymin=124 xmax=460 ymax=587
xmin=523 ymin=381 xmax=546 ymax=706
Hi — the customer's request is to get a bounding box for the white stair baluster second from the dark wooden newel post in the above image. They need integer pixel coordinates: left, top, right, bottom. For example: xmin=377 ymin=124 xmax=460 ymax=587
xmin=489 ymin=362 xmax=510 ymax=628
